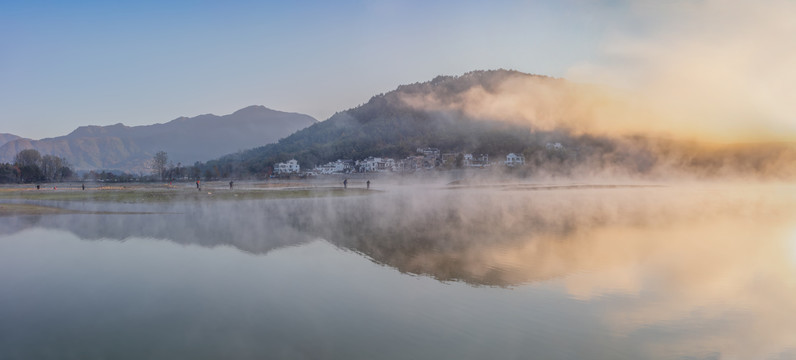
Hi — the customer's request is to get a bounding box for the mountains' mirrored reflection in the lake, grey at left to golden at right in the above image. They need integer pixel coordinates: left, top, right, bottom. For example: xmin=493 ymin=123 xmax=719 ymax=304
xmin=0 ymin=184 xmax=793 ymax=286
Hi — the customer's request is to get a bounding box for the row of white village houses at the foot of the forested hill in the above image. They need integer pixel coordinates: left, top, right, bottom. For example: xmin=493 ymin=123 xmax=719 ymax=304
xmin=274 ymin=148 xmax=525 ymax=175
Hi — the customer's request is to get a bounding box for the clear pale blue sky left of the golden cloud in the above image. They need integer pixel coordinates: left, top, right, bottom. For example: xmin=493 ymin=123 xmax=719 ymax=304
xmin=0 ymin=1 xmax=632 ymax=139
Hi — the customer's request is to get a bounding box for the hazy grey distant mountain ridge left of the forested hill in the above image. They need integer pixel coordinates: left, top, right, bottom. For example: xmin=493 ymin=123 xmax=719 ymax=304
xmin=0 ymin=106 xmax=317 ymax=172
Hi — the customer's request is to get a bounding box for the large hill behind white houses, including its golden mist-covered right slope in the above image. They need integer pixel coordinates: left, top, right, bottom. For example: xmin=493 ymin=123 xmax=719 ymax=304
xmin=204 ymin=70 xmax=796 ymax=179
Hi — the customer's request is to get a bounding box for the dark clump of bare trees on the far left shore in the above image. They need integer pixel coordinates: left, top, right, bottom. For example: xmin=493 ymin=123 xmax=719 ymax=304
xmin=0 ymin=149 xmax=74 ymax=184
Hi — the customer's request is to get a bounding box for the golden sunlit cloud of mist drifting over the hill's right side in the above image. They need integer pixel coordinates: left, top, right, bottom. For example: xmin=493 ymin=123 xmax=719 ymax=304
xmin=401 ymin=0 xmax=796 ymax=143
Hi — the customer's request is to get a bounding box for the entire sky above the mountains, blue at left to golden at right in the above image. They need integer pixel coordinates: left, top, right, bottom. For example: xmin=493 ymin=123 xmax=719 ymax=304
xmin=0 ymin=0 xmax=796 ymax=139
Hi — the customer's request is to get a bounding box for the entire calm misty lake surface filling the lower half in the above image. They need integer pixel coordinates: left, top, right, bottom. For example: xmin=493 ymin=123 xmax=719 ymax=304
xmin=0 ymin=185 xmax=796 ymax=359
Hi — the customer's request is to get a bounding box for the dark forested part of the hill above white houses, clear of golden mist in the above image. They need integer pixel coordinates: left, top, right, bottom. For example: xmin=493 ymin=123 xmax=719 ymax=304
xmin=207 ymin=70 xmax=552 ymax=173
